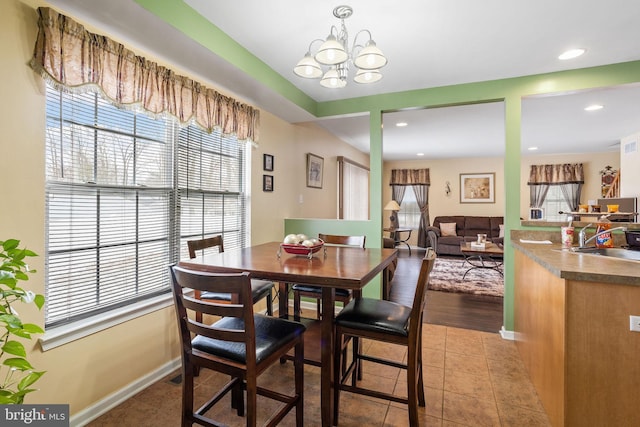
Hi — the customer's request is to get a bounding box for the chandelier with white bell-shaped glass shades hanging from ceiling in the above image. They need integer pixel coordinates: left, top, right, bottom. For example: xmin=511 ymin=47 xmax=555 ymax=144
xmin=293 ymin=6 xmax=387 ymax=89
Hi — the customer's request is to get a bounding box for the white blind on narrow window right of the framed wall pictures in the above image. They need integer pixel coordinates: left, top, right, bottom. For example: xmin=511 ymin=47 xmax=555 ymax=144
xmin=338 ymin=156 xmax=369 ymax=220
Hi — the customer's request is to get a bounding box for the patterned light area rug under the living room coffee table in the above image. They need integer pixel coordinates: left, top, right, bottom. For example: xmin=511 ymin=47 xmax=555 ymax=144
xmin=429 ymin=257 xmax=504 ymax=297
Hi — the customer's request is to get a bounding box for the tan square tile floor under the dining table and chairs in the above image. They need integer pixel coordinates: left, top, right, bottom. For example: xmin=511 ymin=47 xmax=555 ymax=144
xmin=89 ymin=324 xmax=550 ymax=427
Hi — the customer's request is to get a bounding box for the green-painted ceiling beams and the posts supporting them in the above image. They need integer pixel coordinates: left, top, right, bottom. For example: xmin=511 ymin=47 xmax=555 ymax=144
xmin=136 ymin=0 xmax=640 ymax=330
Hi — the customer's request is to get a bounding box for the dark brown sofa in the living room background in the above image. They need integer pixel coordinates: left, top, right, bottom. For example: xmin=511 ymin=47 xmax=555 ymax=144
xmin=427 ymin=215 xmax=504 ymax=255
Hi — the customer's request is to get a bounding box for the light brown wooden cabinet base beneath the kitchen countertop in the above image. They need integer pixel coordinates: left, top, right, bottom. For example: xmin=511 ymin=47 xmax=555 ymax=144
xmin=514 ymin=250 xmax=640 ymax=426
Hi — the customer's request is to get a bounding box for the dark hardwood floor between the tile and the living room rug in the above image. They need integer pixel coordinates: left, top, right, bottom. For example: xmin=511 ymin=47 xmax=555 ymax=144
xmin=391 ymin=248 xmax=503 ymax=332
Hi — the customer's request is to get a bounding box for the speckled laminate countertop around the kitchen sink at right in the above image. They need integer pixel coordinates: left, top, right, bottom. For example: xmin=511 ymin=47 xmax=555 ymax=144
xmin=511 ymin=234 xmax=640 ymax=286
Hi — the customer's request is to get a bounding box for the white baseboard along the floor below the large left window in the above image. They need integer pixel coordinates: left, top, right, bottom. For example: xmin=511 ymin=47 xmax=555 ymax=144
xmin=69 ymin=358 xmax=181 ymax=427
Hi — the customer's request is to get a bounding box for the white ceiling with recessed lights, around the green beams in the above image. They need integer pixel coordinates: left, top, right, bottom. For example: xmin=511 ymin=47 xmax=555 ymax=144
xmin=50 ymin=0 xmax=640 ymax=159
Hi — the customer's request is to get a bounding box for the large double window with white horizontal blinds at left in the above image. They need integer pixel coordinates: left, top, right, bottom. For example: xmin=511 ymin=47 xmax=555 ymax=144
xmin=45 ymin=87 xmax=246 ymax=327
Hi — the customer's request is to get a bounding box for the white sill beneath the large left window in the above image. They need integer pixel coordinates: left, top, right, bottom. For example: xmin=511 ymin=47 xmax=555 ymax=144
xmin=39 ymin=293 xmax=173 ymax=351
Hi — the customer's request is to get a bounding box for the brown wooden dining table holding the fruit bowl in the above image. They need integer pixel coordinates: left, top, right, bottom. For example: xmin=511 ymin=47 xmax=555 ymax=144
xmin=179 ymin=242 xmax=398 ymax=426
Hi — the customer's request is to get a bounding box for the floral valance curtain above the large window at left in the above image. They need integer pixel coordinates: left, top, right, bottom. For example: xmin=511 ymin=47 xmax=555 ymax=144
xmin=30 ymin=7 xmax=260 ymax=142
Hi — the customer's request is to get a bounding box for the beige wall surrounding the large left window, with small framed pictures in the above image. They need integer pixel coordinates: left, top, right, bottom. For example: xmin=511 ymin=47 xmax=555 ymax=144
xmin=0 ymin=0 xmax=368 ymax=414
